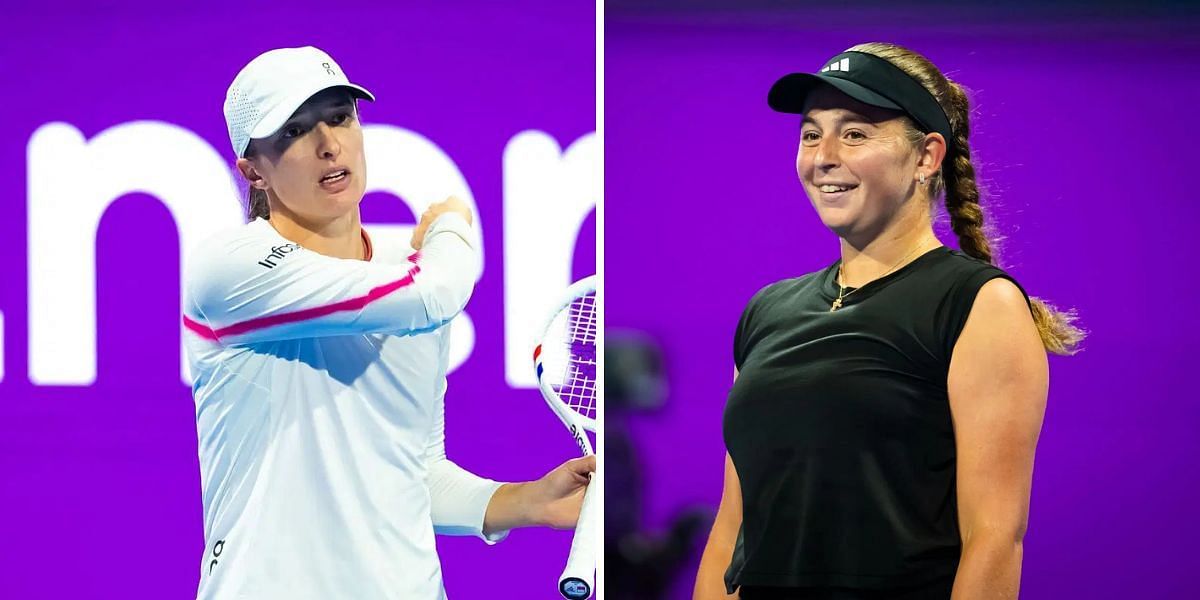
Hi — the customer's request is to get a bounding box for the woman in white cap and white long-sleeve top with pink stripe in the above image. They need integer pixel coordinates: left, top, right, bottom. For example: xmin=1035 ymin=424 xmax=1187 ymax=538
xmin=184 ymin=47 xmax=595 ymax=600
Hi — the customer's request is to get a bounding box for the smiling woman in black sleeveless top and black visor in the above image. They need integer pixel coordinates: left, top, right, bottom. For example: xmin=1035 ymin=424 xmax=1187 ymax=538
xmin=695 ymin=43 xmax=1082 ymax=600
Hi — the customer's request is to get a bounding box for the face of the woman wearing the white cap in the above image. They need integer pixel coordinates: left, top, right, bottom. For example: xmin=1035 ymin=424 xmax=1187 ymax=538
xmin=246 ymin=88 xmax=367 ymax=221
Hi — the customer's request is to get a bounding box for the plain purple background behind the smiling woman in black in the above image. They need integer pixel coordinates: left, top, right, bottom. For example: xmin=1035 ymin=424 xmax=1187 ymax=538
xmin=605 ymin=1 xmax=1200 ymax=599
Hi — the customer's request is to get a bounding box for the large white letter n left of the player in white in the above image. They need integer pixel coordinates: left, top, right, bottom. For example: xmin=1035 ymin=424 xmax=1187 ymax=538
xmin=28 ymin=121 xmax=242 ymax=385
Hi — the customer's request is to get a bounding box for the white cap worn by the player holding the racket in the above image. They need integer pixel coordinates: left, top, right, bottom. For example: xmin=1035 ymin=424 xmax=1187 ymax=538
xmin=224 ymin=46 xmax=374 ymax=157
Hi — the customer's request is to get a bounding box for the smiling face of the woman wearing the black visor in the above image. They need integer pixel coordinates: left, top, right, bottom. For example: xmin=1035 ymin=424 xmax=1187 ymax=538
xmin=796 ymin=85 xmax=918 ymax=240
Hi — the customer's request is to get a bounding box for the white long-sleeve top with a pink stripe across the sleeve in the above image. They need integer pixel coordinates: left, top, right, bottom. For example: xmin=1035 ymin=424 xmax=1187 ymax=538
xmin=184 ymin=214 xmax=503 ymax=600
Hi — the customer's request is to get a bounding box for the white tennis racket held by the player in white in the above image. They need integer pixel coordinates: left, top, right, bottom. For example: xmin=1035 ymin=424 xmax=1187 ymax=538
xmin=533 ymin=275 xmax=601 ymax=600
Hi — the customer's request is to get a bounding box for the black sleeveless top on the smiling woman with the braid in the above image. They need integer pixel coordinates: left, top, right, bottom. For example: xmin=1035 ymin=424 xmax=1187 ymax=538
xmin=724 ymin=246 xmax=1028 ymax=593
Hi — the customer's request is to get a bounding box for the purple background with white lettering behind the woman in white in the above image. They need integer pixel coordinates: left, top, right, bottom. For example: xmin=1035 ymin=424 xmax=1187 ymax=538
xmin=0 ymin=0 xmax=596 ymax=599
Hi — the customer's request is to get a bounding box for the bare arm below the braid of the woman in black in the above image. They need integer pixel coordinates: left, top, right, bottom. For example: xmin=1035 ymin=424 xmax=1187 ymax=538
xmin=948 ymin=278 xmax=1049 ymax=600
